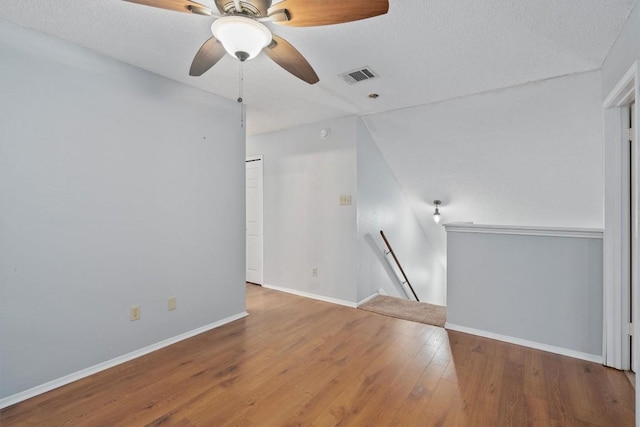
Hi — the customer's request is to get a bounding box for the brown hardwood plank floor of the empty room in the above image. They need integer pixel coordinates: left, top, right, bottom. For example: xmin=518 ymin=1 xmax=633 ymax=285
xmin=0 ymin=285 xmax=634 ymax=427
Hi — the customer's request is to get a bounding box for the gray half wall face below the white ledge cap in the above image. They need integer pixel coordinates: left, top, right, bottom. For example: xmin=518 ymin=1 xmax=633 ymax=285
xmin=447 ymin=232 xmax=602 ymax=356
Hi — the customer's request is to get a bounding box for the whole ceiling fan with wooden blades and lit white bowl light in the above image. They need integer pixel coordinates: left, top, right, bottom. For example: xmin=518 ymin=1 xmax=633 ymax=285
xmin=124 ymin=0 xmax=389 ymax=84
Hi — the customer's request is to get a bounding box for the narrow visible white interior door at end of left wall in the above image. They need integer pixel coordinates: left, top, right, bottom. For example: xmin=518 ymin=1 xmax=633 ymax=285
xmin=246 ymin=156 xmax=263 ymax=285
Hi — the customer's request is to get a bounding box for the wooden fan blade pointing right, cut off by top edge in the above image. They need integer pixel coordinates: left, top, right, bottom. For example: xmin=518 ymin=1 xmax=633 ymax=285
xmin=269 ymin=0 xmax=389 ymax=27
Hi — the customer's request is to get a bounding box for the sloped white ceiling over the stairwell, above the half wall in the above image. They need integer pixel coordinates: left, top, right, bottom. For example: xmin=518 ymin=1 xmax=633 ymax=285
xmin=364 ymin=71 xmax=604 ymax=265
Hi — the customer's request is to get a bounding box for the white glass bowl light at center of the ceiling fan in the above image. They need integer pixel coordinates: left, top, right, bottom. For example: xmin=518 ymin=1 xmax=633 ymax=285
xmin=211 ymin=16 xmax=271 ymax=61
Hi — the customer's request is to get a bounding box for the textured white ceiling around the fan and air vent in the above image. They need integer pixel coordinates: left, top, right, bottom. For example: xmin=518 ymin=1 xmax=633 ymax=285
xmin=0 ymin=0 xmax=635 ymax=134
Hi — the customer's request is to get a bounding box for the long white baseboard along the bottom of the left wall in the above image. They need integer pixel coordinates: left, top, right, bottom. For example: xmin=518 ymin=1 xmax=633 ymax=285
xmin=0 ymin=311 xmax=249 ymax=409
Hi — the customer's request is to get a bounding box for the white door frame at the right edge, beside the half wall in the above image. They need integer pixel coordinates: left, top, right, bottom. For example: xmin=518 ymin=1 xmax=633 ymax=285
xmin=602 ymin=61 xmax=640 ymax=370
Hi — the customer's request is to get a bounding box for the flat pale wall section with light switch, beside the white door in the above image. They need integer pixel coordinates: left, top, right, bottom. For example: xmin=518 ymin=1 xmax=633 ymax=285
xmin=247 ymin=117 xmax=357 ymax=303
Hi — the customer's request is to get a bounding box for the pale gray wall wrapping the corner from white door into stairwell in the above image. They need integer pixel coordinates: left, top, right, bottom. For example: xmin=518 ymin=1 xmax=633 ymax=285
xmin=247 ymin=117 xmax=445 ymax=304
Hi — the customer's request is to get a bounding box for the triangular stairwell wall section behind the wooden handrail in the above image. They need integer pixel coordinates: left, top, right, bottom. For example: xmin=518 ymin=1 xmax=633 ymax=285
xmin=357 ymin=119 xmax=446 ymax=305
